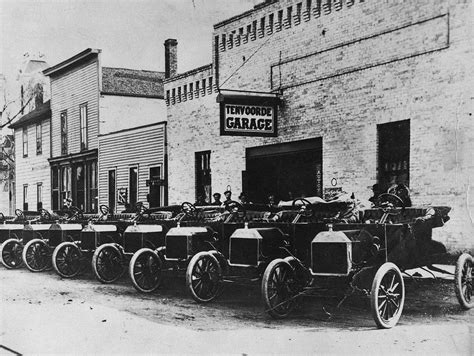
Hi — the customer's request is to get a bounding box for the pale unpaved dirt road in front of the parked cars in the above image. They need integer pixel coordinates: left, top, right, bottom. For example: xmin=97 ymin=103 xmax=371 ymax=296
xmin=0 ymin=267 xmax=474 ymax=355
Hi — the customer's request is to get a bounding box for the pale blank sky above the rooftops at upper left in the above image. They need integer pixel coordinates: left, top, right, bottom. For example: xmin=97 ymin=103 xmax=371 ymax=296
xmin=0 ymin=0 xmax=263 ymax=81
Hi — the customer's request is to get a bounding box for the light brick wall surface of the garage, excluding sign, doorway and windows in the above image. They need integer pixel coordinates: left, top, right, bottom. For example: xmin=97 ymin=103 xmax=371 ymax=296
xmin=165 ymin=0 xmax=474 ymax=250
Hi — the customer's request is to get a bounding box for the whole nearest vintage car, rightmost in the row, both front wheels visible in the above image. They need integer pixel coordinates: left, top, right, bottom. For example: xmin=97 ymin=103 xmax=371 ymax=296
xmin=261 ymin=194 xmax=474 ymax=328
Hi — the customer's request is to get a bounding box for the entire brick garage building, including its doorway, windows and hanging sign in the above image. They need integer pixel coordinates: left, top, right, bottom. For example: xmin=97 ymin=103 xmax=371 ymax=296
xmin=165 ymin=0 xmax=474 ymax=250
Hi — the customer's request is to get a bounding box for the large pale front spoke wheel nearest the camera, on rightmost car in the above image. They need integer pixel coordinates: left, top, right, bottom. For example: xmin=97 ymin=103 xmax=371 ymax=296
xmin=370 ymin=262 xmax=405 ymax=329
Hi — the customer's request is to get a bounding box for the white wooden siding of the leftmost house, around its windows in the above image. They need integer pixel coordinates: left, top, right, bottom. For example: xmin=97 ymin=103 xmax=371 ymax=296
xmin=15 ymin=120 xmax=51 ymax=210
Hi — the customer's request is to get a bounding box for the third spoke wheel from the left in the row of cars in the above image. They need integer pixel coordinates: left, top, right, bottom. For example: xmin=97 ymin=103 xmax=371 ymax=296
xmin=53 ymin=242 xmax=82 ymax=278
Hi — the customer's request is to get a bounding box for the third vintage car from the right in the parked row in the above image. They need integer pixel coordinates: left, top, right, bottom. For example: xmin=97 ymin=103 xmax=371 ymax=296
xmin=129 ymin=202 xmax=233 ymax=293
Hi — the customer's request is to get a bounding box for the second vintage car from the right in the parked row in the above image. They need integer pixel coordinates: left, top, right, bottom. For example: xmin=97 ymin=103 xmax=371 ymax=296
xmin=186 ymin=202 xmax=318 ymax=303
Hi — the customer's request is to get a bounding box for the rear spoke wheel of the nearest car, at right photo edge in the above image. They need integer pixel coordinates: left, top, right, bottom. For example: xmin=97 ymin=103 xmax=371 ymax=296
xmin=454 ymin=253 xmax=474 ymax=309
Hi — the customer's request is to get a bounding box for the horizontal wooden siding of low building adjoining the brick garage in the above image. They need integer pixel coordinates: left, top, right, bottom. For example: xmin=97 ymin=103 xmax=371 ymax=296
xmin=99 ymin=124 xmax=166 ymax=211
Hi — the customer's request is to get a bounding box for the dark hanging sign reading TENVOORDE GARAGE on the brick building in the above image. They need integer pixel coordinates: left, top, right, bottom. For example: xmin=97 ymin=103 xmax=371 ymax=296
xmin=217 ymin=92 xmax=278 ymax=137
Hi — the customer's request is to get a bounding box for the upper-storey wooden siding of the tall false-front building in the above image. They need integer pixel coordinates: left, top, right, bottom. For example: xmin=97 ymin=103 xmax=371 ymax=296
xmin=51 ymin=57 xmax=99 ymax=157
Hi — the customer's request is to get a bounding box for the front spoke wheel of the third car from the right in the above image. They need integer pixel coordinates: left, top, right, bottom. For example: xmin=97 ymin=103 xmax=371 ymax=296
xmin=128 ymin=248 xmax=163 ymax=293
